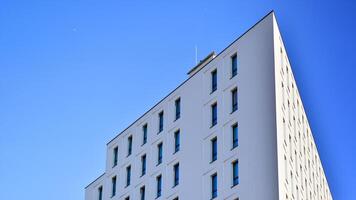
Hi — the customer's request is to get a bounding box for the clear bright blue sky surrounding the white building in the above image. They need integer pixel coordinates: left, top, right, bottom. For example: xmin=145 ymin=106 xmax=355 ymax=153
xmin=0 ymin=0 xmax=356 ymax=200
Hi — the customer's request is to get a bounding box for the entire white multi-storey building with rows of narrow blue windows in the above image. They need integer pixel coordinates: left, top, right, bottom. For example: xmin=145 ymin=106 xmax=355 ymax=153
xmin=85 ymin=12 xmax=332 ymax=200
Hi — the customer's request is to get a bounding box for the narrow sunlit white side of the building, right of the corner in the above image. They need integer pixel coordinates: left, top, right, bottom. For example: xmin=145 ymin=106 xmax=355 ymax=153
xmin=273 ymin=14 xmax=332 ymax=200
